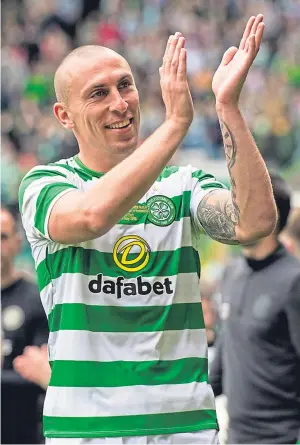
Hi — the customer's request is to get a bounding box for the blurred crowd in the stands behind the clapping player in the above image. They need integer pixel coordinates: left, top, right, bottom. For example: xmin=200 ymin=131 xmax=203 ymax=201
xmin=1 ymin=0 xmax=300 ymax=444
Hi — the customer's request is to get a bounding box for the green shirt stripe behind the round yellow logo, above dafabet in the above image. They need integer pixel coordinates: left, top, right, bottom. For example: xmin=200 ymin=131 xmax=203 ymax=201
xmin=37 ymin=246 xmax=199 ymax=290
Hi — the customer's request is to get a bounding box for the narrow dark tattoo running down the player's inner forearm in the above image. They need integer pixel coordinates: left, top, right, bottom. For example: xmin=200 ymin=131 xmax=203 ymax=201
xmin=220 ymin=120 xmax=241 ymax=224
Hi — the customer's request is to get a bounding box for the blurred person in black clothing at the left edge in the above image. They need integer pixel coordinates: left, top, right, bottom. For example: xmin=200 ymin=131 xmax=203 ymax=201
xmin=0 ymin=208 xmax=48 ymax=443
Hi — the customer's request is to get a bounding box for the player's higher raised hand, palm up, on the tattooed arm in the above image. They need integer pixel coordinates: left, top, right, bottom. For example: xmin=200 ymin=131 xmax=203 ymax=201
xmin=212 ymin=14 xmax=265 ymax=107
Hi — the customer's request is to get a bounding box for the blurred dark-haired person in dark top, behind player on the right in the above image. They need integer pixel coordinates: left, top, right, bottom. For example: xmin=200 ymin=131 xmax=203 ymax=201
xmin=210 ymin=173 xmax=300 ymax=444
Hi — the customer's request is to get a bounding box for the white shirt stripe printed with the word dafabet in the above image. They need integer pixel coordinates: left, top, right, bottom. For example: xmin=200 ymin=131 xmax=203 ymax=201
xmin=41 ymin=273 xmax=201 ymax=306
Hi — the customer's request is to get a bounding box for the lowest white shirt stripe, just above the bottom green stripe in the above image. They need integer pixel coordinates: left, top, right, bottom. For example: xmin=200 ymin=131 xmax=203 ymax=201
xmin=44 ymin=382 xmax=215 ymax=417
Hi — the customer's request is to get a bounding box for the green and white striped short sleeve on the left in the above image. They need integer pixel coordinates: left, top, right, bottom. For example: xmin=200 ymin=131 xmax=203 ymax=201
xmin=19 ymin=165 xmax=77 ymax=240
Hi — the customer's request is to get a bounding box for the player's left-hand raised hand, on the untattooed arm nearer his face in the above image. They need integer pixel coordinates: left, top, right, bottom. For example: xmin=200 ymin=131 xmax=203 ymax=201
xmin=159 ymin=32 xmax=194 ymax=128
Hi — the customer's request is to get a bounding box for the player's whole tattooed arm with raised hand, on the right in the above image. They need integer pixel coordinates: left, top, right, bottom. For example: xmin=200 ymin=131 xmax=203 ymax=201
xmin=198 ymin=14 xmax=277 ymax=244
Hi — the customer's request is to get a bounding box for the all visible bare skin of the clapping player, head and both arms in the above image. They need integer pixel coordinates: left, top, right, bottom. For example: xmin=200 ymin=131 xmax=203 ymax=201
xmin=49 ymin=14 xmax=276 ymax=244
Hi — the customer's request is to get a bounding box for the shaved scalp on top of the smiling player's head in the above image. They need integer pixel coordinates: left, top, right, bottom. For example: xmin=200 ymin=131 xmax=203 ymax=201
xmin=54 ymin=45 xmax=129 ymax=104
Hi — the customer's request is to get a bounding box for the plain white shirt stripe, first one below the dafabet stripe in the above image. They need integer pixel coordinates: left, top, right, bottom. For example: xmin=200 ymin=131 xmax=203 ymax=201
xmin=48 ymin=328 xmax=207 ymax=362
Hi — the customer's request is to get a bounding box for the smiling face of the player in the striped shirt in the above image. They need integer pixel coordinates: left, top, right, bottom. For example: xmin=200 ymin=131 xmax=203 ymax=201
xmin=54 ymin=47 xmax=140 ymax=158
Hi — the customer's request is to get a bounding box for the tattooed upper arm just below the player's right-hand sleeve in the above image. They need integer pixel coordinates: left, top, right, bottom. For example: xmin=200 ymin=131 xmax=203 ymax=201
xmin=197 ymin=190 xmax=239 ymax=244
